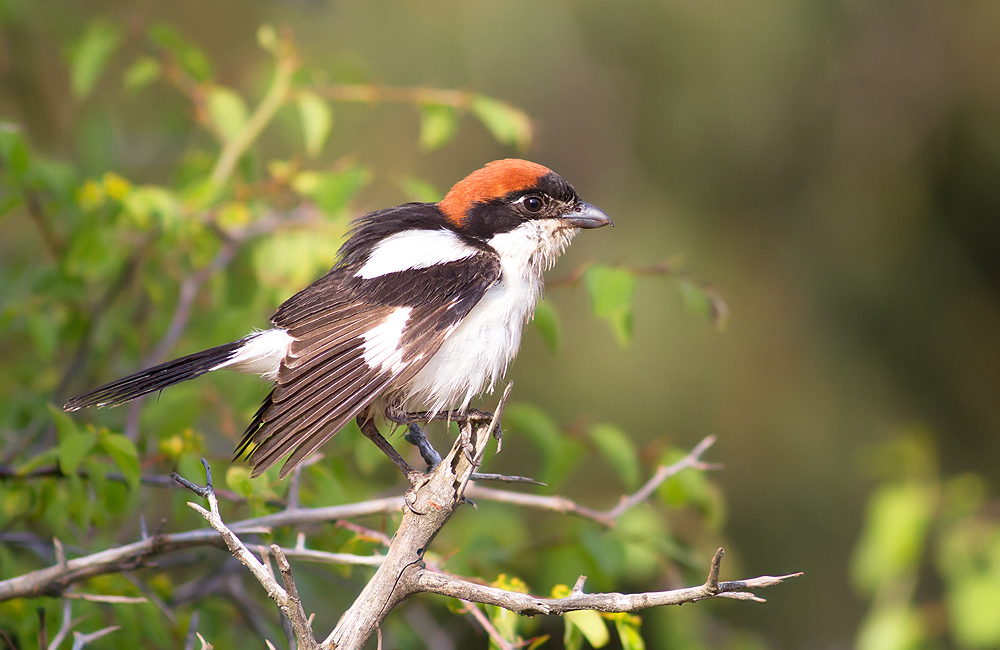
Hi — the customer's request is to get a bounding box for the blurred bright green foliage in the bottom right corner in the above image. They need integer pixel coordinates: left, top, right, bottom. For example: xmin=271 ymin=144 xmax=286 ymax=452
xmin=851 ymin=430 xmax=1000 ymax=650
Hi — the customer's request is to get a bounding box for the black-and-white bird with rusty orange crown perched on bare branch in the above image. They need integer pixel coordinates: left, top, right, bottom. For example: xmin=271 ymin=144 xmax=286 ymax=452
xmin=64 ymin=159 xmax=614 ymax=480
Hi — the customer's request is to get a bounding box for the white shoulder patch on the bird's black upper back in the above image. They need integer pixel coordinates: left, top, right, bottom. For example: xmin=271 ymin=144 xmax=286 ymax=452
xmin=354 ymin=229 xmax=479 ymax=280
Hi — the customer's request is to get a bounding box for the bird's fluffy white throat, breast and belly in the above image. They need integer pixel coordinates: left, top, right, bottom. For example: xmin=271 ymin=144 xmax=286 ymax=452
xmin=405 ymin=219 xmax=578 ymax=413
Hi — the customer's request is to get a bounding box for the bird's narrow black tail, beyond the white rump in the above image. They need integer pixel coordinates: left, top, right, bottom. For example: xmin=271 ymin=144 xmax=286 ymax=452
xmin=63 ymin=339 xmax=247 ymax=411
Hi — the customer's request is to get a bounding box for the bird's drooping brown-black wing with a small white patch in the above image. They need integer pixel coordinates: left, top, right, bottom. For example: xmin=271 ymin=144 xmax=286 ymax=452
xmin=236 ymin=251 xmax=500 ymax=477
